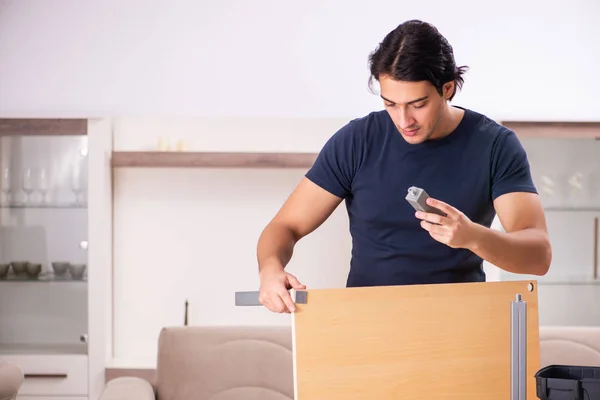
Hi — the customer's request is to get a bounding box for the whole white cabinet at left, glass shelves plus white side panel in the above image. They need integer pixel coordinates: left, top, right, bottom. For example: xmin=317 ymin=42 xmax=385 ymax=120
xmin=0 ymin=119 xmax=112 ymax=400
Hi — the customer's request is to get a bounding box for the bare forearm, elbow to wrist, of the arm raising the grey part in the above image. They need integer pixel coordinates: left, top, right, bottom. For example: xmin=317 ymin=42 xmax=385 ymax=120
xmin=469 ymin=224 xmax=552 ymax=275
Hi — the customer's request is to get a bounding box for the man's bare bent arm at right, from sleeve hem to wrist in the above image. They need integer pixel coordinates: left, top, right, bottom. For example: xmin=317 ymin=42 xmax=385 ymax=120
xmin=469 ymin=192 xmax=552 ymax=276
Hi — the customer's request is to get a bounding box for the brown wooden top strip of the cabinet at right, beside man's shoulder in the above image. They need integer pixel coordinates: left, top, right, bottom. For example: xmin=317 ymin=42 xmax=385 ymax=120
xmin=501 ymin=121 xmax=600 ymax=139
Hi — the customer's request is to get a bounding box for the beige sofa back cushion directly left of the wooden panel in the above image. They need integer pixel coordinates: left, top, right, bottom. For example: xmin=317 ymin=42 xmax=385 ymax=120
xmin=156 ymin=326 xmax=294 ymax=400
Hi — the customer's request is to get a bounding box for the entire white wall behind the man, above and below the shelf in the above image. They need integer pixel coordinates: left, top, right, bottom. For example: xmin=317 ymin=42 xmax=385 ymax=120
xmin=0 ymin=0 xmax=600 ymax=363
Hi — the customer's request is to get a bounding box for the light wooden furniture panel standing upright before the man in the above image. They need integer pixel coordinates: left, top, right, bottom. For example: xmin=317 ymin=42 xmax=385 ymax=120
xmin=293 ymin=281 xmax=540 ymax=400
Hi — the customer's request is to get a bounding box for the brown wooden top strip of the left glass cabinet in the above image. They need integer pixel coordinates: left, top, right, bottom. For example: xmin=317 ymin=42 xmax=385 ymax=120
xmin=0 ymin=118 xmax=88 ymax=136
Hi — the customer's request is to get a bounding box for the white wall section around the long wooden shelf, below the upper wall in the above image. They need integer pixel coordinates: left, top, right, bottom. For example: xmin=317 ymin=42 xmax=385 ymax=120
xmin=114 ymin=118 xmax=351 ymax=364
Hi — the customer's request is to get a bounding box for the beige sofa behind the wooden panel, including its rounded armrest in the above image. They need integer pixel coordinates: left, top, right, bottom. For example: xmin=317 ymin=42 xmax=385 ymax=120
xmin=100 ymin=327 xmax=600 ymax=400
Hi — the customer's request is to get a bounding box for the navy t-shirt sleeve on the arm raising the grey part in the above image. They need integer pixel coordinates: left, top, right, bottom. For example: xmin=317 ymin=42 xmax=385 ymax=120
xmin=492 ymin=130 xmax=537 ymax=200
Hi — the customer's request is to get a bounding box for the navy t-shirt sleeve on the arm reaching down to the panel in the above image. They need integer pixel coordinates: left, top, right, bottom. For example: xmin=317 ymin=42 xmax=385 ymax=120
xmin=306 ymin=122 xmax=357 ymax=199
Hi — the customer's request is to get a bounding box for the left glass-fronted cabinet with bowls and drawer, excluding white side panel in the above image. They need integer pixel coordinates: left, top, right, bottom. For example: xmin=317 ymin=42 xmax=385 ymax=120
xmin=0 ymin=119 xmax=94 ymax=400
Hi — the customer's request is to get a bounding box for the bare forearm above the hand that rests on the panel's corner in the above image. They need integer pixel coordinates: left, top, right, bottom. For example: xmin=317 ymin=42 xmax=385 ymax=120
xmin=257 ymin=222 xmax=297 ymax=272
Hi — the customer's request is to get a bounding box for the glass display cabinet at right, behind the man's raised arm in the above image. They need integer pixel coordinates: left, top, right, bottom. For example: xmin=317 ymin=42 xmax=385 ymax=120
xmin=496 ymin=128 xmax=600 ymax=326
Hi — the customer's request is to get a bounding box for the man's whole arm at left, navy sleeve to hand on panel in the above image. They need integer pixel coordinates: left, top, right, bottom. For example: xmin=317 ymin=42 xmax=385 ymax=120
xmin=256 ymin=123 xmax=362 ymax=312
